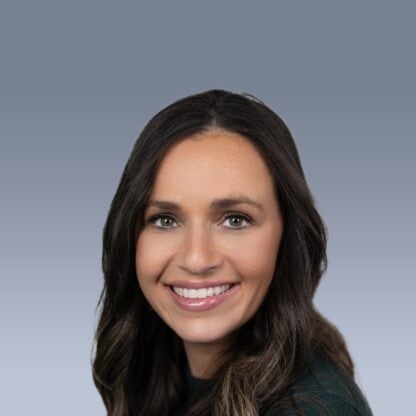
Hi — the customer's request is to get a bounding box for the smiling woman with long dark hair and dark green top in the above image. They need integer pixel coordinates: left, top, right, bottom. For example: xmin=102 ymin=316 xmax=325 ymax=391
xmin=93 ymin=90 xmax=371 ymax=416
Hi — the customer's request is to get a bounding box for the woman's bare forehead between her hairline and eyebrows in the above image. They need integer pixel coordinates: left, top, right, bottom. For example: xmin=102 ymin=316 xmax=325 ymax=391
xmin=152 ymin=131 xmax=273 ymax=203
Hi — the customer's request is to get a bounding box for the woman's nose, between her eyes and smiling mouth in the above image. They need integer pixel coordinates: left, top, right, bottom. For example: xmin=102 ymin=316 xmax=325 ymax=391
xmin=178 ymin=221 xmax=223 ymax=276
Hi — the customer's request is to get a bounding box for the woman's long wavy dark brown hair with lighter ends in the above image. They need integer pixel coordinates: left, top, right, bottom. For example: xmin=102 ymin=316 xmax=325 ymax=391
xmin=93 ymin=90 xmax=353 ymax=416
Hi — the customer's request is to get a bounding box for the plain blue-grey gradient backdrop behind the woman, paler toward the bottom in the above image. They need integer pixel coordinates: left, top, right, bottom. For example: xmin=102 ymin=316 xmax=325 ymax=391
xmin=0 ymin=0 xmax=416 ymax=416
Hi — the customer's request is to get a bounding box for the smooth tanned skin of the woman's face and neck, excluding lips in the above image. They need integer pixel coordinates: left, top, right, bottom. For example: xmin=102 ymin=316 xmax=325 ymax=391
xmin=136 ymin=130 xmax=283 ymax=378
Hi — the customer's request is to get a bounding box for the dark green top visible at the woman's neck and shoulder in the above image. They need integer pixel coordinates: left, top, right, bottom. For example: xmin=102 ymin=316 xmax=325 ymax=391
xmin=186 ymin=354 xmax=372 ymax=416
